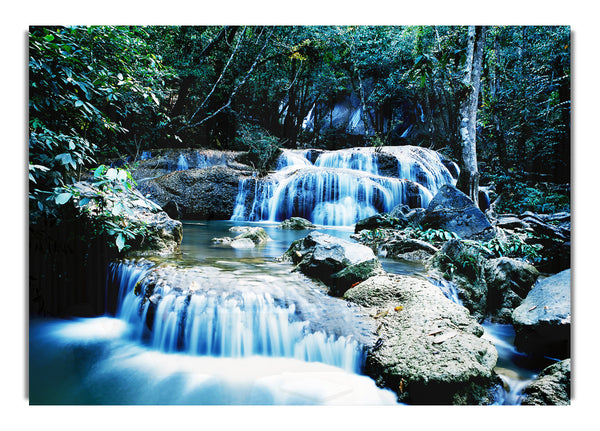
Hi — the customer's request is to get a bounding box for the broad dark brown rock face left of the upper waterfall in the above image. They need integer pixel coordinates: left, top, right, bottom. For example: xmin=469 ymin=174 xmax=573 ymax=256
xmin=138 ymin=165 xmax=246 ymax=220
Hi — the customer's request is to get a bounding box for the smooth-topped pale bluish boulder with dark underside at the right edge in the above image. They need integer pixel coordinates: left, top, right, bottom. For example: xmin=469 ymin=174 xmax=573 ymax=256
xmin=512 ymin=269 xmax=571 ymax=359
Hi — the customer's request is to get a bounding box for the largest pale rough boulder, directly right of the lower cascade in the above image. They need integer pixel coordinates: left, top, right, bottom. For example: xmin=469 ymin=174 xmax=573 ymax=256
xmin=344 ymin=274 xmax=500 ymax=404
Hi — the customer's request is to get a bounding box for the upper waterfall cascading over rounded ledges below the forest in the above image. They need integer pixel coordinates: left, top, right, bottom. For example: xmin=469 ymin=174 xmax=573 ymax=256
xmin=232 ymin=146 xmax=456 ymax=226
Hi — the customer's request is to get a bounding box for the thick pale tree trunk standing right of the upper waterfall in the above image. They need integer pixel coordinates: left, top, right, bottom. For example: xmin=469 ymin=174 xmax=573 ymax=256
xmin=457 ymin=26 xmax=485 ymax=205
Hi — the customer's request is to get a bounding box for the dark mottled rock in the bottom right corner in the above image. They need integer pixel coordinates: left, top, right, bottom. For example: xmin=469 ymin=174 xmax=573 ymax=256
xmin=521 ymin=359 xmax=571 ymax=406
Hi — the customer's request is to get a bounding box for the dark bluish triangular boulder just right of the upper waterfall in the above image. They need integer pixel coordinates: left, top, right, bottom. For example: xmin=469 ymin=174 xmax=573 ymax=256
xmin=421 ymin=185 xmax=495 ymax=240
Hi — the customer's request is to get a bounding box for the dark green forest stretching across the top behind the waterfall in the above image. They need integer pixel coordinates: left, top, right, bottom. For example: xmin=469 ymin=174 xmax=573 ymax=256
xmin=29 ymin=26 xmax=571 ymax=223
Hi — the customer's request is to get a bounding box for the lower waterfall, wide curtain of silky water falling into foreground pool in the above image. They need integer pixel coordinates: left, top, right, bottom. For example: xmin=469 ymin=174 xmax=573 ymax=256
xmin=110 ymin=261 xmax=364 ymax=373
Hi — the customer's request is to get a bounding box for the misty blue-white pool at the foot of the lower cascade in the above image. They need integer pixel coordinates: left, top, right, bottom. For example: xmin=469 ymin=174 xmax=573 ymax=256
xmin=29 ymin=317 xmax=396 ymax=405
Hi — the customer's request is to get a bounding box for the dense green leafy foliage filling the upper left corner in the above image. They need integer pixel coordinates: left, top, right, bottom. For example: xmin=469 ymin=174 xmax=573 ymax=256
xmin=29 ymin=26 xmax=173 ymax=218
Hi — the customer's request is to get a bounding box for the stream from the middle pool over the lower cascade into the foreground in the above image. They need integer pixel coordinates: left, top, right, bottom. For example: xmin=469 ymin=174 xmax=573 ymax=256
xmin=29 ymin=221 xmax=541 ymax=405
